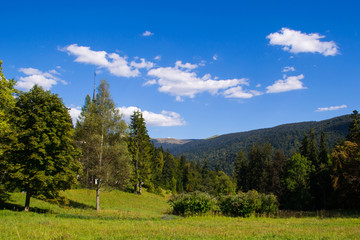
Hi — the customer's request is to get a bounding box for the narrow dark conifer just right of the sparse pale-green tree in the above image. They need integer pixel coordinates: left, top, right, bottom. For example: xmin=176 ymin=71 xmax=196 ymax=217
xmin=128 ymin=111 xmax=152 ymax=194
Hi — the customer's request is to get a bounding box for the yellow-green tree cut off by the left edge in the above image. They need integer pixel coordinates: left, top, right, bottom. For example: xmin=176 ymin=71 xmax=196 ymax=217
xmin=0 ymin=60 xmax=17 ymax=200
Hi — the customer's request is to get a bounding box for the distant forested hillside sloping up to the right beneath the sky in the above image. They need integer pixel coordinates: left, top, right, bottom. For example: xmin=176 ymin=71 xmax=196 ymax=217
xmin=153 ymin=115 xmax=351 ymax=174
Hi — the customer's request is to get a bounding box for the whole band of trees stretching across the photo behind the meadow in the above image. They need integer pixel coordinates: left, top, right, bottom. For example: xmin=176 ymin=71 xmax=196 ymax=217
xmin=0 ymin=60 xmax=360 ymax=214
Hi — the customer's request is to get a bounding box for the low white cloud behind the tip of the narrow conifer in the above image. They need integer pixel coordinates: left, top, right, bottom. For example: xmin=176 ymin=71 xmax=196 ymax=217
xmin=119 ymin=106 xmax=186 ymax=127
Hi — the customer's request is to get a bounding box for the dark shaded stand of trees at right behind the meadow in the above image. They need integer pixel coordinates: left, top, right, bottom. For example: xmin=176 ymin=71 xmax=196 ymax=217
xmin=235 ymin=111 xmax=360 ymax=210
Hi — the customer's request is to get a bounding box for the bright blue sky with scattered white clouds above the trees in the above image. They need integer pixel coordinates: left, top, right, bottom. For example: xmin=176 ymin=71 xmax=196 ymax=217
xmin=0 ymin=0 xmax=360 ymax=139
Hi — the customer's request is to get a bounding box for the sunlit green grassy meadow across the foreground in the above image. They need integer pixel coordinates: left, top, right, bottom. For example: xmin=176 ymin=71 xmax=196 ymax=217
xmin=0 ymin=190 xmax=360 ymax=239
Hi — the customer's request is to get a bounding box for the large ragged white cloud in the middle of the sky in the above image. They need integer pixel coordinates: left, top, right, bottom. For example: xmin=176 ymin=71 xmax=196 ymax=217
xmin=148 ymin=61 xmax=249 ymax=101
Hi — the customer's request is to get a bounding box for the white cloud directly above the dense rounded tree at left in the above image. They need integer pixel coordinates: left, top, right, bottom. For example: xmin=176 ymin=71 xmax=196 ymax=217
xmin=16 ymin=68 xmax=67 ymax=90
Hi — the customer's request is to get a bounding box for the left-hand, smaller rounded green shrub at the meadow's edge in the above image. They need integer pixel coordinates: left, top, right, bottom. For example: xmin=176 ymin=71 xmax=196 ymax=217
xmin=169 ymin=192 xmax=218 ymax=216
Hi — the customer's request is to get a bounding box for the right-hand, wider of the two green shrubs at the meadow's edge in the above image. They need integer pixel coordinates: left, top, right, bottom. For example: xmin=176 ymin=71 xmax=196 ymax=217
xmin=218 ymin=190 xmax=279 ymax=217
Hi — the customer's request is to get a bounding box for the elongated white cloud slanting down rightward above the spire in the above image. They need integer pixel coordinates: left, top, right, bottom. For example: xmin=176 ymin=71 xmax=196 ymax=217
xmin=61 ymin=44 xmax=154 ymax=77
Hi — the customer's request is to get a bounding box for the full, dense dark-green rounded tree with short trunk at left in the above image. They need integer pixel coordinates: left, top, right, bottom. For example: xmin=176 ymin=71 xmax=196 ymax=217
xmin=10 ymin=85 xmax=81 ymax=211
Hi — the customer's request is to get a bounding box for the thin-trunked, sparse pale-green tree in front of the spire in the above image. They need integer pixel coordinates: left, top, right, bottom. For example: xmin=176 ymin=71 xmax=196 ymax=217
xmin=76 ymin=80 xmax=132 ymax=210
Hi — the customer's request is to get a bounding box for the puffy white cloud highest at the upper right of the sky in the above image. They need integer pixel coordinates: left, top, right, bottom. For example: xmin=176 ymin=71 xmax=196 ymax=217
xmin=266 ymin=28 xmax=339 ymax=56
